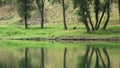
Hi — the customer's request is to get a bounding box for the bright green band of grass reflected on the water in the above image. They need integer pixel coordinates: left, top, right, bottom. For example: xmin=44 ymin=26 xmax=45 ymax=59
xmin=0 ymin=40 xmax=120 ymax=49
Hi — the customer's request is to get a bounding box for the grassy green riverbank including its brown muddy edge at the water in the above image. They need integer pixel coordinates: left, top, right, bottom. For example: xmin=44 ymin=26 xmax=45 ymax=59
xmin=0 ymin=25 xmax=120 ymax=41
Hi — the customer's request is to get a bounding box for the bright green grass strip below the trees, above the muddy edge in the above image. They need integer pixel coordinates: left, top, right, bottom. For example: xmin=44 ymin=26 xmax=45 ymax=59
xmin=0 ymin=24 xmax=120 ymax=38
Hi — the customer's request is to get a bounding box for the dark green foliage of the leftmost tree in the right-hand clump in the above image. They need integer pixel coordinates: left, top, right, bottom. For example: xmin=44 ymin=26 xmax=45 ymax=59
xmin=73 ymin=0 xmax=91 ymax=22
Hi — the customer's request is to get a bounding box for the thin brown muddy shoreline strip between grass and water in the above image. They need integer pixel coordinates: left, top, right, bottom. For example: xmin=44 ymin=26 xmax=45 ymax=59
xmin=0 ymin=36 xmax=120 ymax=41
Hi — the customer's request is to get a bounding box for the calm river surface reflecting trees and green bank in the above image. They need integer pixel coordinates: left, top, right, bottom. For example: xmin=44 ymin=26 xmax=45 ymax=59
xmin=0 ymin=42 xmax=120 ymax=68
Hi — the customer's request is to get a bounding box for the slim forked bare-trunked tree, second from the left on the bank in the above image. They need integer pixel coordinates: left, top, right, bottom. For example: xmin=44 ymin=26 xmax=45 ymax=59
xmin=36 ymin=0 xmax=45 ymax=28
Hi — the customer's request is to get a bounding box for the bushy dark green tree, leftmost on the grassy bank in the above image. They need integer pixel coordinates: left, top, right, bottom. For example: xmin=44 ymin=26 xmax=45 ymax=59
xmin=18 ymin=0 xmax=33 ymax=29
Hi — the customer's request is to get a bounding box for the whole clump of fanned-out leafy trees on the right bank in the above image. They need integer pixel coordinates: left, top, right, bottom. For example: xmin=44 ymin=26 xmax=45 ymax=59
xmin=73 ymin=0 xmax=110 ymax=32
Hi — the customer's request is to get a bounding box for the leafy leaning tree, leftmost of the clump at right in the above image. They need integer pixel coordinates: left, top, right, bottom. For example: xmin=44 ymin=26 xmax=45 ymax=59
xmin=73 ymin=0 xmax=92 ymax=32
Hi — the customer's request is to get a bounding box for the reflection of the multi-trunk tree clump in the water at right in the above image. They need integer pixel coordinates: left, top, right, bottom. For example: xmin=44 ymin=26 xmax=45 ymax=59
xmin=78 ymin=46 xmax=111 ymax=68
